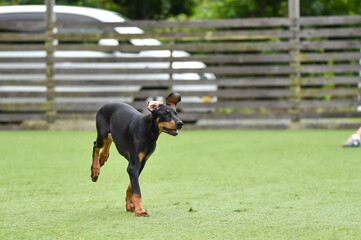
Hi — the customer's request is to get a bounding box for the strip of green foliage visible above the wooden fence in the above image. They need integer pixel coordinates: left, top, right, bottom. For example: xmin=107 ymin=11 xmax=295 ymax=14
xmin=0 ymin=0 xmax=361 ymax=19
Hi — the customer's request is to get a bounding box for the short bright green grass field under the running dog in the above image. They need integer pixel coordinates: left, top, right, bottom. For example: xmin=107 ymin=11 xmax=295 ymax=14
xmin=0 ymin=130 xmax=361 ymax=239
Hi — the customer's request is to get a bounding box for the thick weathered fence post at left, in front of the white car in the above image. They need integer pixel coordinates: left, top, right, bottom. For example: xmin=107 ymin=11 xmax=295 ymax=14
xmin=45 ymin=0 xmax=56 ymax=124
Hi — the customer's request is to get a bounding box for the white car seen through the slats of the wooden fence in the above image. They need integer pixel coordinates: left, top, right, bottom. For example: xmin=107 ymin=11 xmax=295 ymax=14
xmin=0 ymin=5 xmax=217 ymax=110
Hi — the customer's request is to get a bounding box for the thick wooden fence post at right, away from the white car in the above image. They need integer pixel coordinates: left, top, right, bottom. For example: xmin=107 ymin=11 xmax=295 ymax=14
xmin=288 ymin=0 xmax=302 ymax=128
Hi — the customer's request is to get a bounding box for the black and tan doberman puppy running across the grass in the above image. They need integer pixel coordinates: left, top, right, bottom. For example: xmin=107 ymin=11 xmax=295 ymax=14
xmin=91 ymin=92 xmax=183 ymax=217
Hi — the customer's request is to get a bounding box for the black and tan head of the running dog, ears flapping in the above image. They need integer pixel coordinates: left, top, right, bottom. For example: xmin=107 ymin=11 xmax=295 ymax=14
xmin=148 ymin=92 xmax=183 ymax=136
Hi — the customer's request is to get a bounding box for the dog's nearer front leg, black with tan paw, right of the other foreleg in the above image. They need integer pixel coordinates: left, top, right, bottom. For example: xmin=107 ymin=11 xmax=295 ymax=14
xmin=127 ymin=156 xmax=150 ymax=217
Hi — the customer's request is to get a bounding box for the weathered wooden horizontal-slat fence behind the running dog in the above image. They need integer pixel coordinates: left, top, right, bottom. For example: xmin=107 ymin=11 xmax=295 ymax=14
xmin=0 ymin=10 xmax=361 ymax=128
